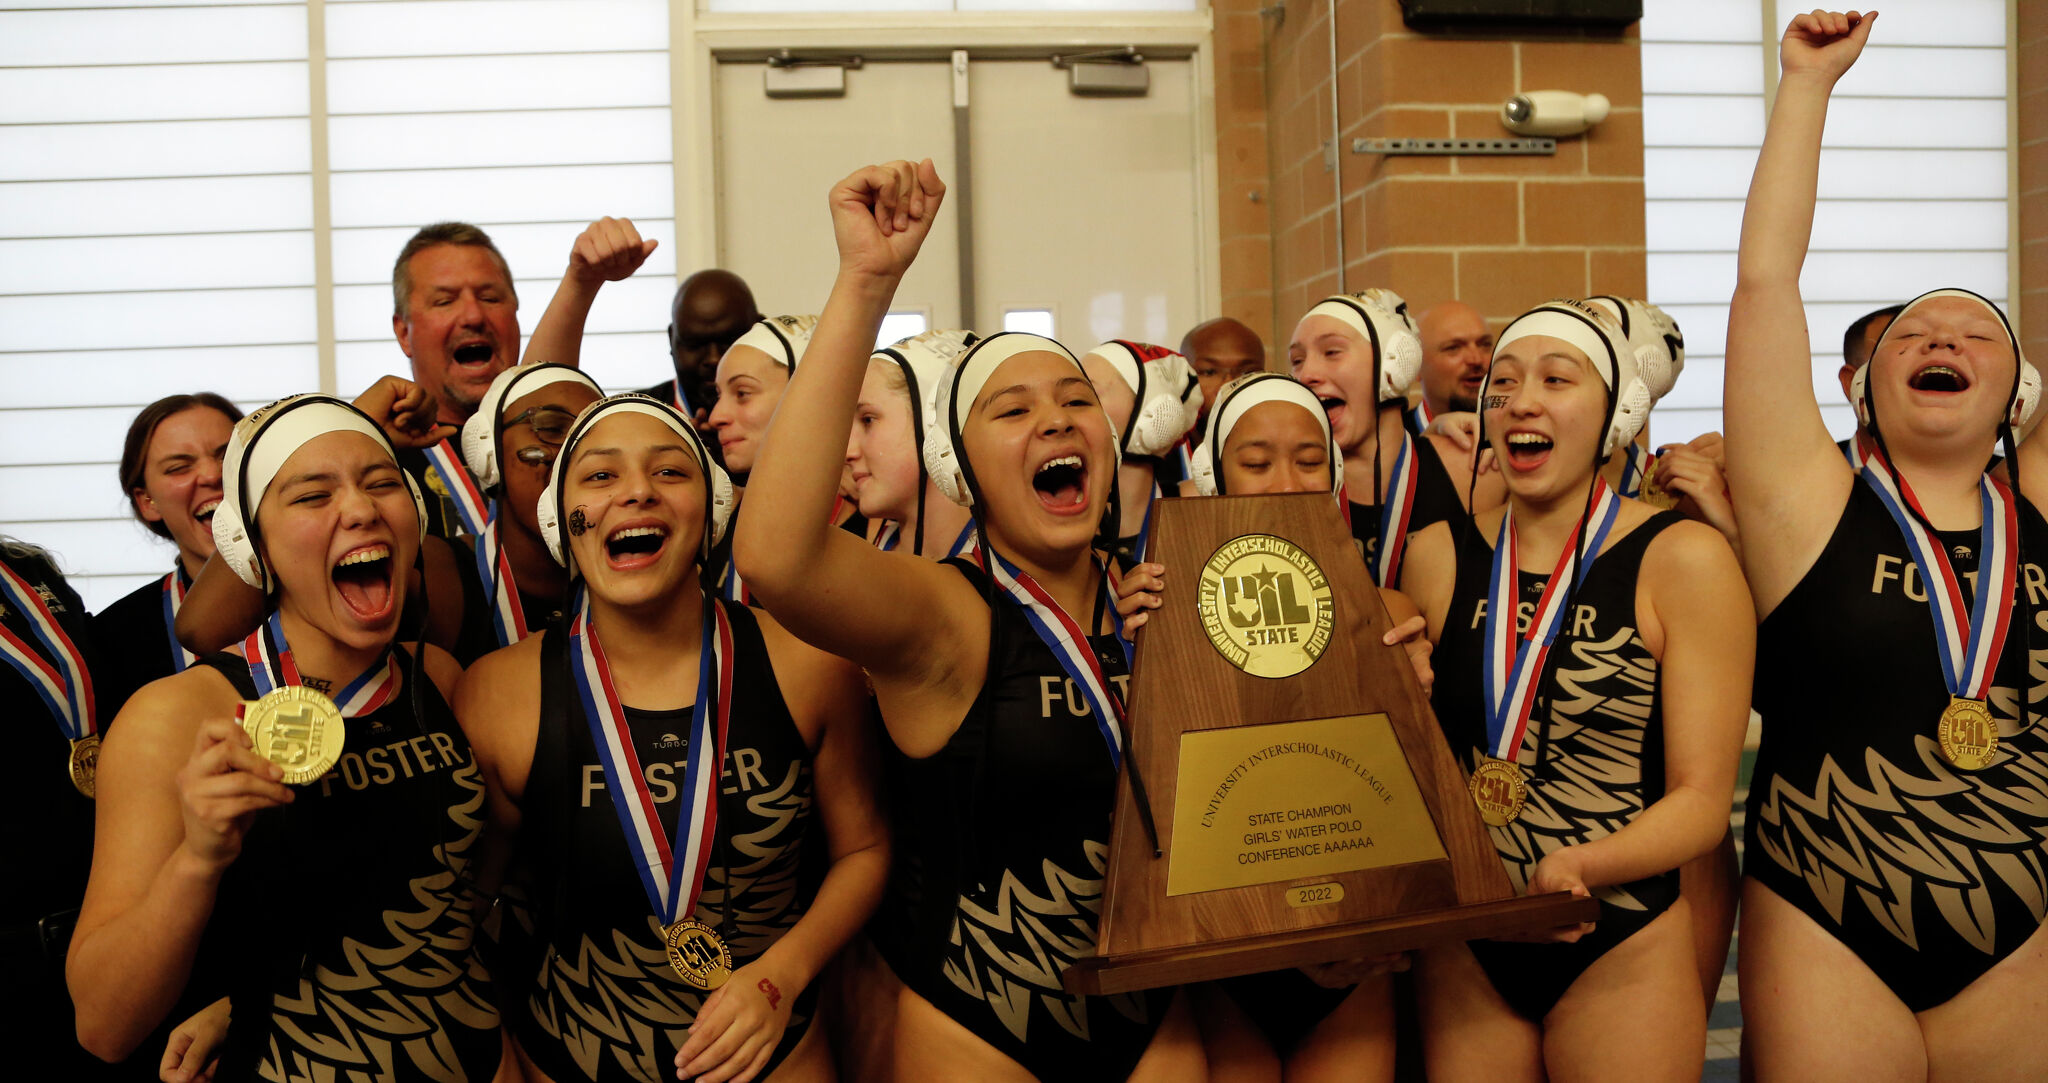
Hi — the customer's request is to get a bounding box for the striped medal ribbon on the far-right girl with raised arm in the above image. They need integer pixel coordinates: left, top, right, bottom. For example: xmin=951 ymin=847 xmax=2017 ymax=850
xmin=1864 ymin=450 xmax=2019 ymax=700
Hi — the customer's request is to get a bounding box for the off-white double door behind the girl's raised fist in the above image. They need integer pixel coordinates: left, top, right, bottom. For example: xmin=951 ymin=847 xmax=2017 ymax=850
xmin=715 ymin=57 xmax=1204 ymax=352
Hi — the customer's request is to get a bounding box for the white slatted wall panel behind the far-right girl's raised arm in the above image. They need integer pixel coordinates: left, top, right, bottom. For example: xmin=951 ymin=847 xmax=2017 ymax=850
xmin=1642 ymin=0 xmax=2009 ymax=442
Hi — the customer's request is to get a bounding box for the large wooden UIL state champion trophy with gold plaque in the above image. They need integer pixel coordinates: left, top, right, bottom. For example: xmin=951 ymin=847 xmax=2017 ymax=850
xmin=1065 ymin=493 xmax=1599 ymax=993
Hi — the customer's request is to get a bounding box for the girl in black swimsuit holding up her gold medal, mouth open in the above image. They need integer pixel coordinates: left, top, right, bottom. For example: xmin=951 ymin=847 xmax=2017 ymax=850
xmin=68 ymin=395 xmax=500 ymax=1081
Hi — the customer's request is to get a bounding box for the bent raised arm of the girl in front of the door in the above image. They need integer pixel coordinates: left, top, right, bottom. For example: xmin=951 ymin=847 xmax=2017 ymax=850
xmin=733 ymin=160 xmax=987 ymax=691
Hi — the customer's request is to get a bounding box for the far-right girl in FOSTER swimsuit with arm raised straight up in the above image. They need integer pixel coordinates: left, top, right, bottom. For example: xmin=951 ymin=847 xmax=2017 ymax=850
xmin=1726 ymin=12 xmax=2048 ymax=1079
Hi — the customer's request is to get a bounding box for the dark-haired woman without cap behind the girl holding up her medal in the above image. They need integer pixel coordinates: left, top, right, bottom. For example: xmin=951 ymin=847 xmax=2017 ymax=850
xmin=92 ymin=391 xmax=242 ymax=719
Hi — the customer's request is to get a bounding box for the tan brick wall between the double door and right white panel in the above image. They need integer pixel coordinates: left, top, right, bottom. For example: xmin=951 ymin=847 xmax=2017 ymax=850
xmin=1214 ymin=0 xmax=1645 ymax=354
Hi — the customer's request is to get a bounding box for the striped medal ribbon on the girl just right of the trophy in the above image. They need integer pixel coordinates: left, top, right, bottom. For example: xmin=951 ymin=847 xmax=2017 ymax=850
xmin=1481 ymin=475 xmax=1622 ymax=764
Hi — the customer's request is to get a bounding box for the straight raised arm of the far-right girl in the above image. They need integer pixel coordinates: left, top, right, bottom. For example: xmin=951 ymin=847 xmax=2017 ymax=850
xmin=1722 ymin=12 xmax=1876 ymax=612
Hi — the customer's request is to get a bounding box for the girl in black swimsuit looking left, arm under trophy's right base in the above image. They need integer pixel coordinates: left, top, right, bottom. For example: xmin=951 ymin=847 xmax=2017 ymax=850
xmin=1401 ymin=301 xmax=1753 ymax=1079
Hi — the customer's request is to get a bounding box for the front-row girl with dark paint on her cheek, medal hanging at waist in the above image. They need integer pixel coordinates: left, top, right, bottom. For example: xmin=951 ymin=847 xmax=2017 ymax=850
xmin=457 ymin=395 xmax=889 ymax=1083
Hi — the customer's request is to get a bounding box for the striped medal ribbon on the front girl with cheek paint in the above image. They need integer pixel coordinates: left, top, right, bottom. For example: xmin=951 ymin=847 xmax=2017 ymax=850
xmin=569 ymin=596 xmax=733 ymax=927
